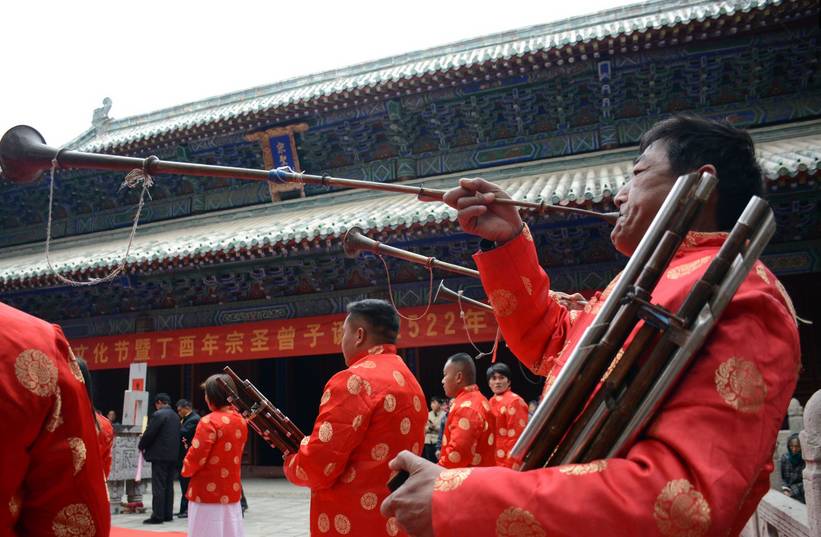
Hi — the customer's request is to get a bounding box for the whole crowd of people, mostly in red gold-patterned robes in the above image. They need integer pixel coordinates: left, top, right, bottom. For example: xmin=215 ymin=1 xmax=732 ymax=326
xmin=0 ymin=117 xmax=803 ymax=537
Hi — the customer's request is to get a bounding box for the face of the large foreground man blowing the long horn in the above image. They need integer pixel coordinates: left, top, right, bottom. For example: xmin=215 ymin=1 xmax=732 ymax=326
xmin=610 ymin=140 xmax=676 ymax=256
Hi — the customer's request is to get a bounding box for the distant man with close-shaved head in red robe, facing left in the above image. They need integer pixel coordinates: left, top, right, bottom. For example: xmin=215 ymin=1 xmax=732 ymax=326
xmin=439 ymin=352 xmax=496 ymax=468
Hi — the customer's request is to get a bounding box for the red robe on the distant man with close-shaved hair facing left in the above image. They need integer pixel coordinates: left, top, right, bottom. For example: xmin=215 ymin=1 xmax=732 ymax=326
xmin=439 ymin=384 xmax=496 ymax=468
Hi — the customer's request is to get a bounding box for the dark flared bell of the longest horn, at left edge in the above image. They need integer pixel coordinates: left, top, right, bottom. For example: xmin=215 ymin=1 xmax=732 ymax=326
xmin=0 ymin=125 xmax=57 ymax=184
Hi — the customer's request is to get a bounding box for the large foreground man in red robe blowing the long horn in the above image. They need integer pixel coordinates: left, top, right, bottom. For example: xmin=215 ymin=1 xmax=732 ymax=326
xmin=382 ymin=117 xmax=800 ymax=537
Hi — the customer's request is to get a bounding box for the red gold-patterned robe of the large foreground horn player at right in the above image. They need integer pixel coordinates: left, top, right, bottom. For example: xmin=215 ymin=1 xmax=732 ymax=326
xmin=433 ymin=229 xmax=800 ymax=537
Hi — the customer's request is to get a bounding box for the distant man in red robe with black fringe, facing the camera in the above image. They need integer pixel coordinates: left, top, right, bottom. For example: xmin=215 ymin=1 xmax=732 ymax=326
xmin=487 ymin=362 xmax=527 ymax=468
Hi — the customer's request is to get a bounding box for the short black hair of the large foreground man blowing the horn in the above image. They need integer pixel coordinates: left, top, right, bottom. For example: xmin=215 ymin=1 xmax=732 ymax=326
xmin=640 ymin=115 xmax=764 ymax=231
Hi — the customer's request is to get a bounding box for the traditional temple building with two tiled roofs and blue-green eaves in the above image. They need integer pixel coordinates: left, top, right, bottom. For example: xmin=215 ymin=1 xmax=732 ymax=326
xmin=0 ymin=0 xmax=821 ymax=471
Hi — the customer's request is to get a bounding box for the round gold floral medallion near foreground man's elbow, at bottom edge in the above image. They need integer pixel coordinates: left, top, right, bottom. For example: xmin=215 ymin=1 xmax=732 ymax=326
xmin=653 ymin=479 xmax=710 ymax=537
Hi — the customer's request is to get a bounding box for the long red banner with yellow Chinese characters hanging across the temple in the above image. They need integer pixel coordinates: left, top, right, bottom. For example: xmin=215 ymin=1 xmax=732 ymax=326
xmin=70 ymin=304 xmax=496 ymax=369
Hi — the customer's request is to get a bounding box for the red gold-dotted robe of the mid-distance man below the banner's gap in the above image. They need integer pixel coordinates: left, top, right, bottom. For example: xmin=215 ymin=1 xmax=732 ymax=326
xmin=285 ymin=345 xmax=428 ymax=536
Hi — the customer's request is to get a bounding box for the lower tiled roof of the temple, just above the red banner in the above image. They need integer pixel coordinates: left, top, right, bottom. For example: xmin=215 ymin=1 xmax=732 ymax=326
xmin=0 ymin=129 xmax=821 ymax=288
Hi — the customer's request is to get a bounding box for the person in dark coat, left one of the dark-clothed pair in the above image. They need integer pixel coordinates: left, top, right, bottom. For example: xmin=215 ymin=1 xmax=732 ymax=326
xmin=138 ymin=393 xmax=181 ymax=524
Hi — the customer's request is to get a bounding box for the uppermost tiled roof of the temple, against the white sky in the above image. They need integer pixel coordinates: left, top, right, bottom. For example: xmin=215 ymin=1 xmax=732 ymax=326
xmin=68 ymin=0 xmax=793 ymax=152
